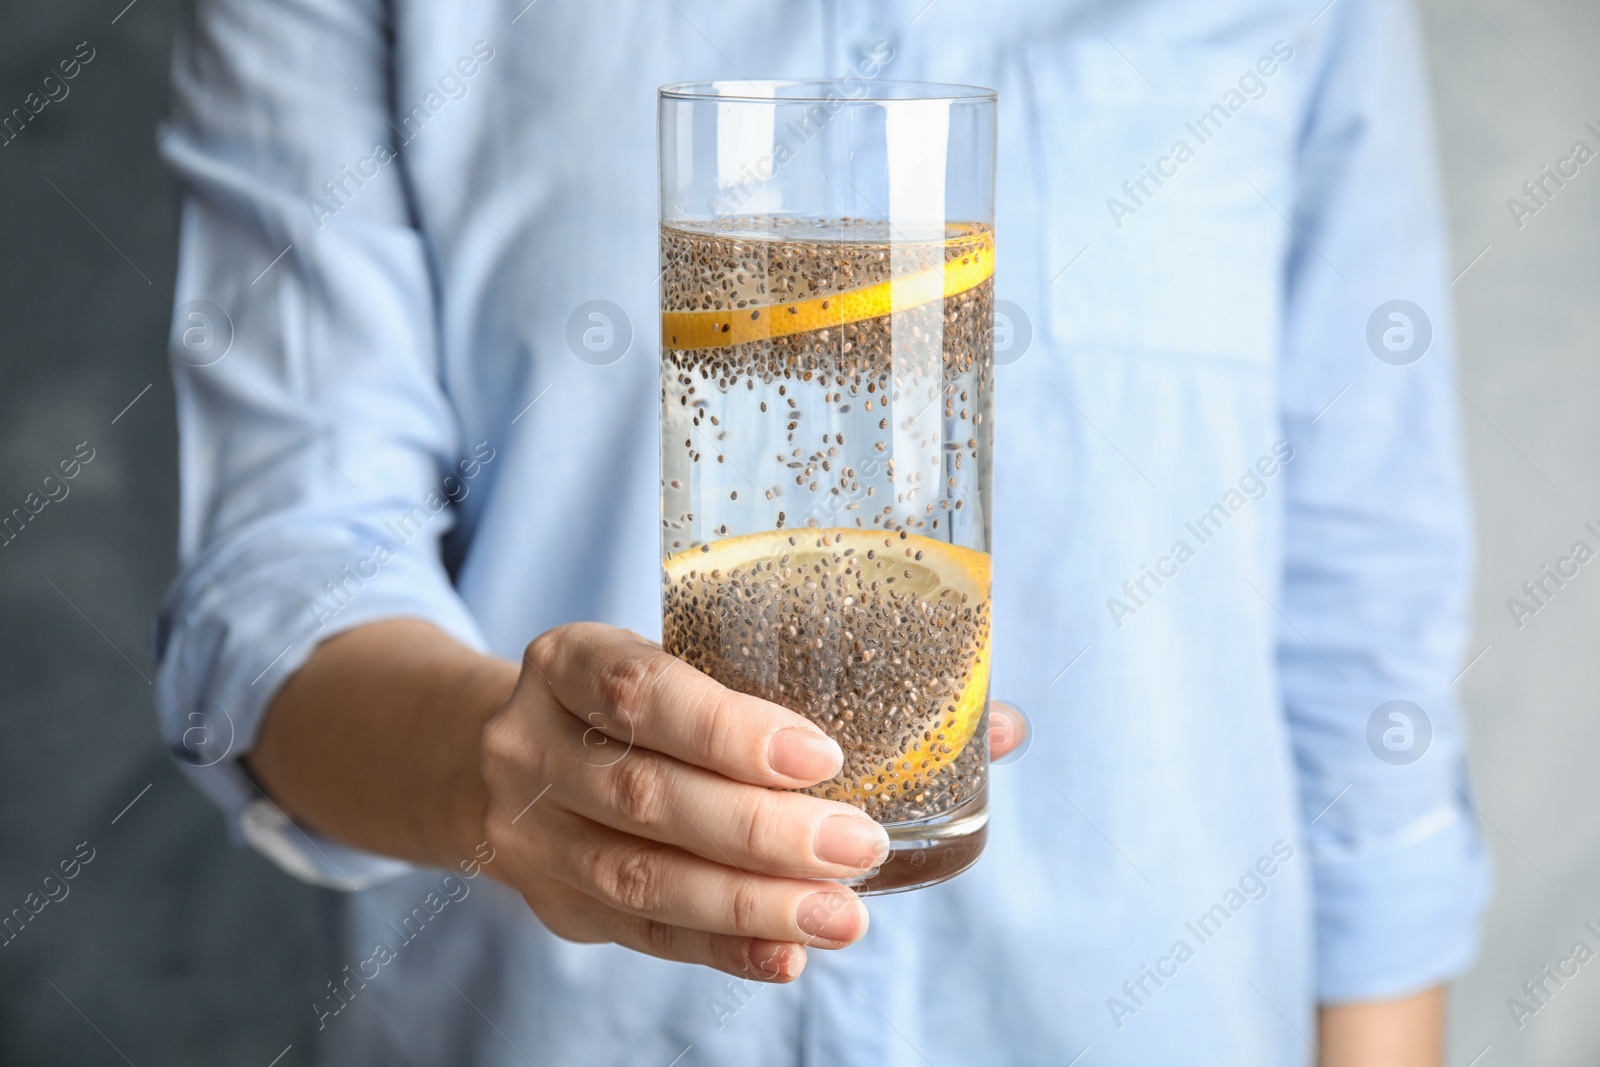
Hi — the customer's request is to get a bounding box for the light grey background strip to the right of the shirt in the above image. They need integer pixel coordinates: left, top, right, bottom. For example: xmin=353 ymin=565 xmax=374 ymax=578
xmin=1424 ymin=0 xmax=1600 ymax=1067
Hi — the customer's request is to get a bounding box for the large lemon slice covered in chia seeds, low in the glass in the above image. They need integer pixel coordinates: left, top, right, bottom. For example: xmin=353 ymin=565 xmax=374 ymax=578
xmin=664 ymin=528 xmax=990 ymax=821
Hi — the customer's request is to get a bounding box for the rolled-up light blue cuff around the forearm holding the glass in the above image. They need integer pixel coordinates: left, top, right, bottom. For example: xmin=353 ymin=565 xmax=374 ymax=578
xmin=155 ymin=523 xmax=485 ymax=893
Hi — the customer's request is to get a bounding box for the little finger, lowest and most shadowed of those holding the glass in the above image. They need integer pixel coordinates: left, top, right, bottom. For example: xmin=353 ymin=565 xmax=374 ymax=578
xmin=528 ymin=880 xmax=806 ymax=985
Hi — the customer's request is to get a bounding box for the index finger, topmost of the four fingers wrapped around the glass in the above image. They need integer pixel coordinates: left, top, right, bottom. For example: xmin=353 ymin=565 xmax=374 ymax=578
xmin=528 ymin=622 xmax=845 ymax=789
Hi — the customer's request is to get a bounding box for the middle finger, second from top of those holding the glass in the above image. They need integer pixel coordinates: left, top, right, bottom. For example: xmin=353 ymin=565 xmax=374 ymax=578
xmin=540 ymin=723 xmax=890 ymax=878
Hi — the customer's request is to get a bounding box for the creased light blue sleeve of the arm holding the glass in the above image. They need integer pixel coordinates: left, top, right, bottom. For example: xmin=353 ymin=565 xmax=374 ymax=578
xmin=155 ymin=0 xmax=493 ymax=889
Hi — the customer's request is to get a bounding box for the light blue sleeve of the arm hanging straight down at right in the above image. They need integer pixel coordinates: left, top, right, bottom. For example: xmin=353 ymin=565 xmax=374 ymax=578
xmin=1278 ymin=0 xmax=1490 ymax=1001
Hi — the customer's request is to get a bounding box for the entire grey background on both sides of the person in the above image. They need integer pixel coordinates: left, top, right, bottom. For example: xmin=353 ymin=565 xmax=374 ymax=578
xmin=0 ymin=0 xmax=1600 ymax=1067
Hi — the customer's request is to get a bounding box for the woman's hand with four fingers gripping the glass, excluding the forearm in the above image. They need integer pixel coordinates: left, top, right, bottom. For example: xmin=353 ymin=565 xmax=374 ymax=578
xmin=482 ymin=622 xmax=888 ymax=982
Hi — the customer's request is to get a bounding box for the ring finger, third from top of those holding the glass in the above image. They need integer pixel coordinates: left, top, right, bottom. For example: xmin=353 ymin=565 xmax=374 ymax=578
xmin=539 ymin=811 xmax=867 ymax=963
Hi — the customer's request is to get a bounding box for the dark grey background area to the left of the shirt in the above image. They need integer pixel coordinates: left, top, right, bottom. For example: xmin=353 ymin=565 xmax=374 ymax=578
xmin=0 ymin=0 xmax=318 ymax=1067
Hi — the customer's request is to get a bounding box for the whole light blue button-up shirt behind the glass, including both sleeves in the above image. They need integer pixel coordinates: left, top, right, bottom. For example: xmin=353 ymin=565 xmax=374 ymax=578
xmin=158 ymin=0 xmax=1488 ymax=1067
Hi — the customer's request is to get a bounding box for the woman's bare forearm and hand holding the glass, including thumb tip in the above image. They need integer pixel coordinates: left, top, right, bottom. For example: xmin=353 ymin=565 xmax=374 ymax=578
xmin=246 ymin=619 xmax=1026 ymax=982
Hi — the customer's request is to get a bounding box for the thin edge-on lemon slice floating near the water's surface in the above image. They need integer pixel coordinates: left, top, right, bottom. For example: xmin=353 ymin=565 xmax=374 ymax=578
xmin=661 ymin=232 xmax=995 ymax=350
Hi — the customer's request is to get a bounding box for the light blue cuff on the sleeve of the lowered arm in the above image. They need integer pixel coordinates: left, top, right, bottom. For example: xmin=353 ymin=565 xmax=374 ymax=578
xmin=1312 ymin=801 xmax=1490 ymax=1003
